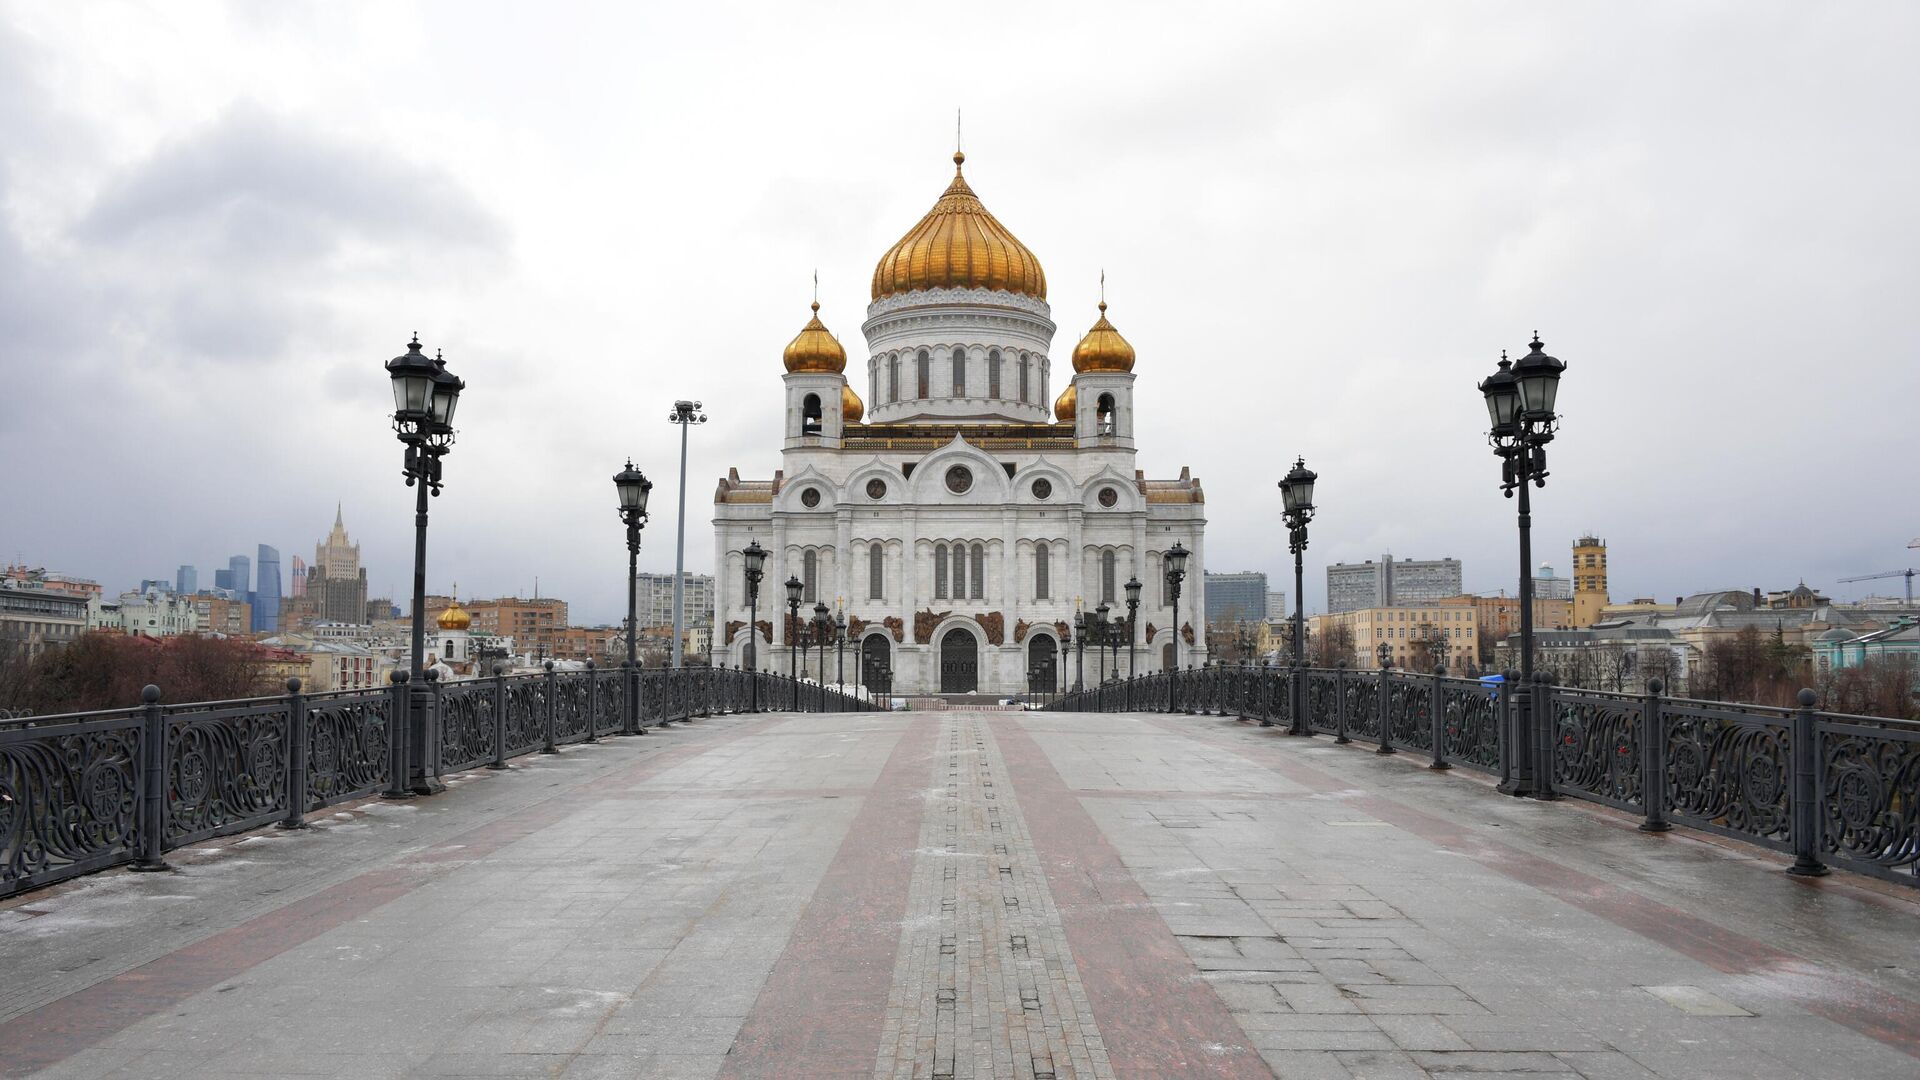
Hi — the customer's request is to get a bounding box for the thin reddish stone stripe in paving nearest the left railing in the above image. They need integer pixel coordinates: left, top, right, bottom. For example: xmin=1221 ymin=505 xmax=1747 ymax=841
xmin=0 ymin=717 xmax=785 ymax=1076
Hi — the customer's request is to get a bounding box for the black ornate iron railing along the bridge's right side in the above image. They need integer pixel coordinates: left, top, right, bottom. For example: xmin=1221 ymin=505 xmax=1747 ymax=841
xmin=1046 ymin=667 xmax=1920 ymax=884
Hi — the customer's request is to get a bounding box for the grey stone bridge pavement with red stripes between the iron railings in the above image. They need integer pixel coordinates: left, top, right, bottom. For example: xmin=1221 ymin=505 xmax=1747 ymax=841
xmin=0 ymin=713 xmax=1920 ymax=1080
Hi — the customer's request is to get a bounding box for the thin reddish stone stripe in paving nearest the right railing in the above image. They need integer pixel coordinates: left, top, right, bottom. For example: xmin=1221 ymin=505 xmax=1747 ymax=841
xmin=1152 ymin=717 xmax=1920 ymax=1057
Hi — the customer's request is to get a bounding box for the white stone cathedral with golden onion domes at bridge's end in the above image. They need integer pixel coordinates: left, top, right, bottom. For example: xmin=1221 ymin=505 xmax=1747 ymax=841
xmin=714 ymin=154 xmax=1206 ymax=696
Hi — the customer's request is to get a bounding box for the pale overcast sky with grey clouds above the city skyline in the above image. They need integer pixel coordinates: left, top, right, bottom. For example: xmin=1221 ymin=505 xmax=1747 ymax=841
xmin=0 ymin=0 xmax=1920 ymax=623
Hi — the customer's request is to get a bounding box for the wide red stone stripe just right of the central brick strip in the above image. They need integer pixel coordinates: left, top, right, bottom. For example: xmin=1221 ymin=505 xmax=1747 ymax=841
xmin=989 ymin=715 xmax=1273 ymax=1078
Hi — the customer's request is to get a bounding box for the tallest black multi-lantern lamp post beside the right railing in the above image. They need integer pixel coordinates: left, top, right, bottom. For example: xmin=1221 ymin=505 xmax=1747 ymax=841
xmin=1480 ymin=332 xmax=1567 ymax=796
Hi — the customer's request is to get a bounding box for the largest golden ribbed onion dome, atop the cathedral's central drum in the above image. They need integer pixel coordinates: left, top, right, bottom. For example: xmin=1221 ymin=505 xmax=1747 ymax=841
xmin=874 ymin=152 xmax=1046 ymax=300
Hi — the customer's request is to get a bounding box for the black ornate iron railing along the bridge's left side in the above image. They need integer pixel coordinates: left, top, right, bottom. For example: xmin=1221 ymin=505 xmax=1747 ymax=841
xmin=0 ymin=667 xmax=881 ymax=896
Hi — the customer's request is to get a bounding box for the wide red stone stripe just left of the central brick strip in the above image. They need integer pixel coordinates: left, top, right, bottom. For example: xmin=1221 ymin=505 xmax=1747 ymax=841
xmin=720 ymin=715 xmax=939 ymax=1080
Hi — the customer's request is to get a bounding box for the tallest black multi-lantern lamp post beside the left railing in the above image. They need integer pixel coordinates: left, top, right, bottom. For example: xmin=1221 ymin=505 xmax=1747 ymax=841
xmin=384 ymin=334 xmax=467 ymax=798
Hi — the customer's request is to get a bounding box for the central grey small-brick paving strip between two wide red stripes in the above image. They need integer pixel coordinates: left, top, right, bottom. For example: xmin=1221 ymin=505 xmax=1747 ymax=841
xmin=874 ymin=711 xmax=1114 ymax=1080
